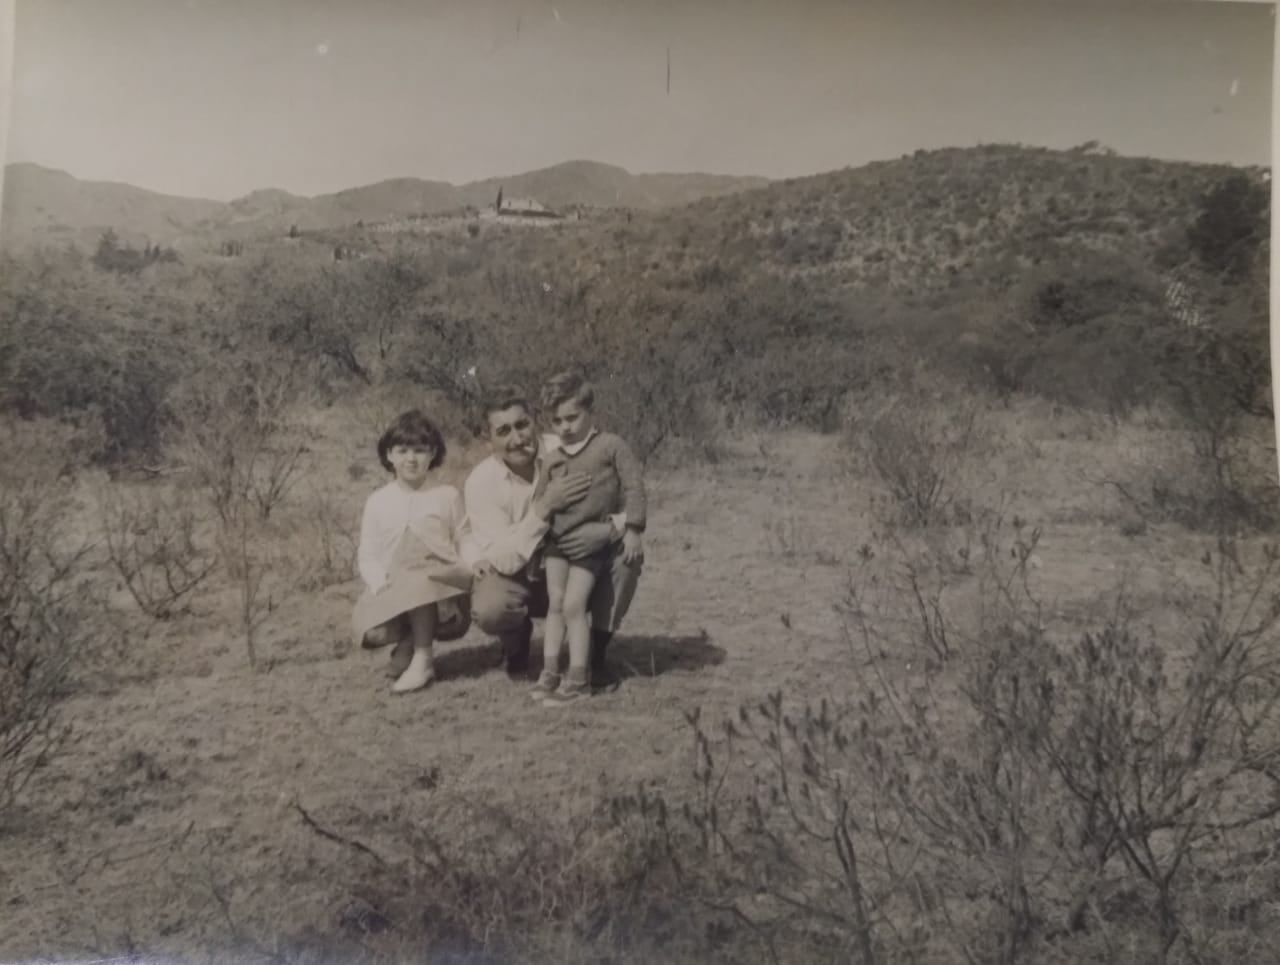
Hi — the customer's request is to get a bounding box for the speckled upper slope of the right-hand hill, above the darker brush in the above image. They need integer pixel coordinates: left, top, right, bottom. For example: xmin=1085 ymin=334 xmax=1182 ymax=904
xmin=427 ymin=146 xmax=1262 ymax=293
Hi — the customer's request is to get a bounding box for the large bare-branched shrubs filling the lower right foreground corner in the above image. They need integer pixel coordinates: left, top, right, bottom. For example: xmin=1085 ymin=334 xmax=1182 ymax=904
xmin=618 ymin=523 xmax=1280 ymax=962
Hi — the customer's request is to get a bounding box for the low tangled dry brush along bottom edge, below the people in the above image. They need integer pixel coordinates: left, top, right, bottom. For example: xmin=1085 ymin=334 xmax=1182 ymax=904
xmin=292 ymin=788 xmax=680 ymax=965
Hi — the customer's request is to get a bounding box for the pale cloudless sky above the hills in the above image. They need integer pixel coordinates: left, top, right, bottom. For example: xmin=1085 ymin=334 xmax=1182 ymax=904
xmin=0 ymin=0 xmax=1275 ymax=201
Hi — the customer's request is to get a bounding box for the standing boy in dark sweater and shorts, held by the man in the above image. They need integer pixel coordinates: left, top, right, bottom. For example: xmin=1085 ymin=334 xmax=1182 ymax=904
xmin=532 ymin=372 xmax=645 ymax=705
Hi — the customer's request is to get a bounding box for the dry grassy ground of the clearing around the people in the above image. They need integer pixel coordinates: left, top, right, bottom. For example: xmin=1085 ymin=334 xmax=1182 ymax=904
xmin=0 ymin=391 xmax=1280 ymax=961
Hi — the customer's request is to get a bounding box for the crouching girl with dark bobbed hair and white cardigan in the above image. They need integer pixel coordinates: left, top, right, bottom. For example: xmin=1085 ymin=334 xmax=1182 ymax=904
xmin=352 ymin=410 xmax=471 ymax=694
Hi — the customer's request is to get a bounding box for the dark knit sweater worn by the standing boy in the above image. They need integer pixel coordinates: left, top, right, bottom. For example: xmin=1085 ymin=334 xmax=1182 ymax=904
xmin=544 ymin=433 xmax=646 ymax=538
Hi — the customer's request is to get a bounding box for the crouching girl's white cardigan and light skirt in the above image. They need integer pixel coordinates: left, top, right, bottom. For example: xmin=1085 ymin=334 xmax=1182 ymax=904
xmin=351 ymin=480 xmax=472 ymax=645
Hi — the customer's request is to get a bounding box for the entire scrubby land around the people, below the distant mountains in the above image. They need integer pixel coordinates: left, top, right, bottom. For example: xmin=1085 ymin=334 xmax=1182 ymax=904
xmin=0 ymin=142 xmax=1280 ymax=965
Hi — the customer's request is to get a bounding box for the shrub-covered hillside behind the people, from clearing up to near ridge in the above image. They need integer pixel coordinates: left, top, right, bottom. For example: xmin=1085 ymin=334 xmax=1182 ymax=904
xmin=0 ymin=146 xmax=1270 ymax=468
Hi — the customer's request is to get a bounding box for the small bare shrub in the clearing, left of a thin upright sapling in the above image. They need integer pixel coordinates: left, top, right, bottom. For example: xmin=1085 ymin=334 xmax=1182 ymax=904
xmin=97 ymin=484 xmax=218 ymax=619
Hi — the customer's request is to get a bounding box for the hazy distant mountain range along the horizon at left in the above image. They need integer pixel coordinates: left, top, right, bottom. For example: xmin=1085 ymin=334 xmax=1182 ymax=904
xmin=0 ymin=161 xmax=769 ymax=248
